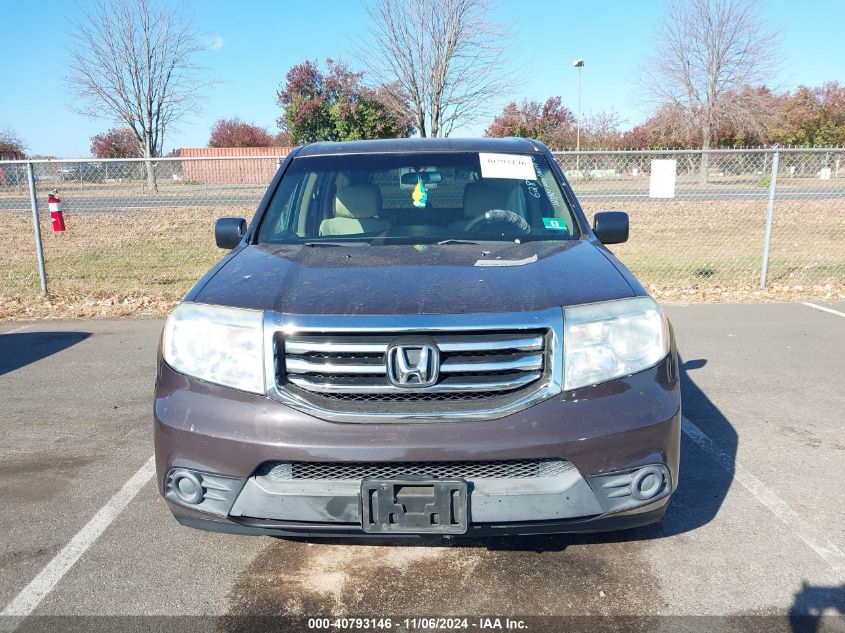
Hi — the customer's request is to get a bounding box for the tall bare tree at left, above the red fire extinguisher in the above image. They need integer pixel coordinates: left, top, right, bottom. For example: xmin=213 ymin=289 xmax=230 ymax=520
xmin=68 ymin=0 xmax=204 ymax=190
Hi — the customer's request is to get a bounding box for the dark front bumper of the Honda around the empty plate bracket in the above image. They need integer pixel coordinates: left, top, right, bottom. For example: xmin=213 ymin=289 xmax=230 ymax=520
xmin=155 ymin=355 xmax=680 ymax=536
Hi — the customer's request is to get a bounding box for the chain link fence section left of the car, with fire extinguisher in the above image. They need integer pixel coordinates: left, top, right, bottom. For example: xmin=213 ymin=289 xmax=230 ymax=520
xmin=0 ymin=157 xmax=280 ymax=318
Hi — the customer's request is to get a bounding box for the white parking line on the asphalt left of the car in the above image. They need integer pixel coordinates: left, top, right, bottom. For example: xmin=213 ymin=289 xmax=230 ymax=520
xmin=0 ymin=456 xmax=155 ymax=617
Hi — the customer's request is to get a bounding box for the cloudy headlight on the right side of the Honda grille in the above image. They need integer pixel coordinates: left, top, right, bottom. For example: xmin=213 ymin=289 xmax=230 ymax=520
xmin=563 ymin=297 xmax=669 ymax=390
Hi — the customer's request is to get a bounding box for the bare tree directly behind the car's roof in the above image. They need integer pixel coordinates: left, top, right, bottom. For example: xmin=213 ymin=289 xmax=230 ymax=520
xmin=360 ymin=0 xmax=513 ymax=137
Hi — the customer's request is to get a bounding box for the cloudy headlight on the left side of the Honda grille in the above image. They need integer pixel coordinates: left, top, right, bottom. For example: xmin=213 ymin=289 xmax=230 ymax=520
xmin=163 ymin=303 xmax=264 ymax=393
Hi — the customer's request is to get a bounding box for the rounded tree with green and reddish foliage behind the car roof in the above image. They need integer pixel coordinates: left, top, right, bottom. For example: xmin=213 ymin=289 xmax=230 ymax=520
xmin=277 ymin=59 xmax=414 ymax=144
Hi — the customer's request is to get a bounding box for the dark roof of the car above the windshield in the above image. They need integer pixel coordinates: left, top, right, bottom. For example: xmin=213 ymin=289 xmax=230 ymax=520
xmin=297 ymin=137 xmax=545 ymax=156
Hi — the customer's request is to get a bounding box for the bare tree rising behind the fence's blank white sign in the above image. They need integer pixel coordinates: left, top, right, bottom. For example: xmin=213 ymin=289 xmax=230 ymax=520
xmin=642 ymin=0 xmax=777 ymax=179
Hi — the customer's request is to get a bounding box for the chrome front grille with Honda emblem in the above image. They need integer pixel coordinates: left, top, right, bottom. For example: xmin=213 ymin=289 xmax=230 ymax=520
xmin=264 ymin=308 xmax=563 ymax=422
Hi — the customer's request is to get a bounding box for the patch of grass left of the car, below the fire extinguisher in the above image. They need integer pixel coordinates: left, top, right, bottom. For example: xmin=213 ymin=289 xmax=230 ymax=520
xmin=0 ymin=207 xmax=234 ymax=318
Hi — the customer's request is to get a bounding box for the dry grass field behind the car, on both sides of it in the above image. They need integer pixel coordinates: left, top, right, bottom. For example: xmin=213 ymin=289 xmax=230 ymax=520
xmin=0 ymin=197 xmax=845 ymax=319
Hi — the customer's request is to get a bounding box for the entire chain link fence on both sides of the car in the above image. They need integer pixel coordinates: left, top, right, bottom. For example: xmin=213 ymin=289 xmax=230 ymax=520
xmin=0 ymin=149 xmax=845 ymax=318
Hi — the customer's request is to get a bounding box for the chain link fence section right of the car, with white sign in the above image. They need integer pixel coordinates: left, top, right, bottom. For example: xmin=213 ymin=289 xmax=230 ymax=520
xmin=555 ymin=149 xmax=845 ymax=300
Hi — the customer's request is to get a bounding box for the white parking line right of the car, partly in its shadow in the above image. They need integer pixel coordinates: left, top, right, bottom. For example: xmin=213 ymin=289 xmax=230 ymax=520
xmin=681 ymin=418 xmax=845 ymax=574
